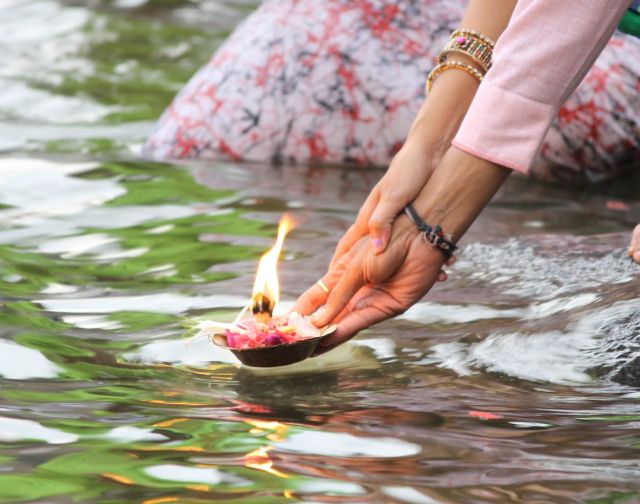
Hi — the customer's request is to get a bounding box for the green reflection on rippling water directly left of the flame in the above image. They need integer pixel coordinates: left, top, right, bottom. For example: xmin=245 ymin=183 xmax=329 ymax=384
xmin=0 ymin=162 xmax=272 ymax=296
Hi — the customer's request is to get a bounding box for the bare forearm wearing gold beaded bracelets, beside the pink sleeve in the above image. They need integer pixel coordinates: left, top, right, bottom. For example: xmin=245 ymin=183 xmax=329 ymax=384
xmin=407 ymin=0 xmax=516 ymax=153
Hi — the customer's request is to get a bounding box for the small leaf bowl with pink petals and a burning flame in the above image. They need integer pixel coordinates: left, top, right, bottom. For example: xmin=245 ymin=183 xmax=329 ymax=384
xmin=198 ymin=214 xmax=336 ymax=367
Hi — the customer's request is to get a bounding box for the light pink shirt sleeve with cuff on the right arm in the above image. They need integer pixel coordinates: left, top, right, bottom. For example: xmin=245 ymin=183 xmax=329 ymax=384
xmin=453 ymin=0 xmax=630 ymax=173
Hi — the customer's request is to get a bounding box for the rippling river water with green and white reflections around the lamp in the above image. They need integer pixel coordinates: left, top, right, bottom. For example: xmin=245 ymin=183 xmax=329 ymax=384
xmin=0 ymin=0 xmax=640 ymax=504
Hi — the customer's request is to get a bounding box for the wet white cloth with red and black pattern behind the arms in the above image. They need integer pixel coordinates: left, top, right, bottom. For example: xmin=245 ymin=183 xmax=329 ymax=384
xmin=145 ymin=0 xmax=640 ymax=181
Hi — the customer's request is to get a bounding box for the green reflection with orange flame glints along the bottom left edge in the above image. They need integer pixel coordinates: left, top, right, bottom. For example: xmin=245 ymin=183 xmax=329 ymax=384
xmin=0 ymin=417 xmax=361 ymax=502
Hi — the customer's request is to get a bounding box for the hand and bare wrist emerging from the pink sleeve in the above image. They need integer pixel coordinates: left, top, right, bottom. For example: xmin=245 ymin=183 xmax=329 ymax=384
xmin=294 ymin=147 xmax=511 ymax=353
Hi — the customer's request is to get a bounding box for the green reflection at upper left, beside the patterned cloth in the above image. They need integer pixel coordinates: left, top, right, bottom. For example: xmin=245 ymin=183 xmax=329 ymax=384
xmin=31 ymin=13 xmax=222 ymax=122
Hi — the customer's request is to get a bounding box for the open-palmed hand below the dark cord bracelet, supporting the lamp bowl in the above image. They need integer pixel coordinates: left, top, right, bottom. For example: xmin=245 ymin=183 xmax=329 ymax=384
xmin=293 ymin=217 xmax=444 ymax=355
